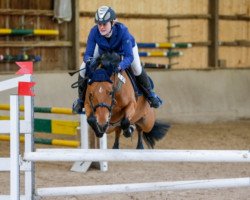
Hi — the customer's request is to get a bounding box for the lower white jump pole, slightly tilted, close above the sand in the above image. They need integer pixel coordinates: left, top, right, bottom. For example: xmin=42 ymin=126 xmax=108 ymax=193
xmin=36 ymin=178 xmax=250 ymax=196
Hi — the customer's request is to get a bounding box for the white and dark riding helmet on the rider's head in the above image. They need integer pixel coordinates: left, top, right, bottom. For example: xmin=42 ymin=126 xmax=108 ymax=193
xmin=95 ymin=6 xmax=116 ymax=24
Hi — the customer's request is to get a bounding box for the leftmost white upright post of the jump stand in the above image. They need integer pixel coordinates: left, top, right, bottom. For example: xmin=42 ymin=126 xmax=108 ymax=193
xmin=10 ymin=95 xmax=20 ymax=200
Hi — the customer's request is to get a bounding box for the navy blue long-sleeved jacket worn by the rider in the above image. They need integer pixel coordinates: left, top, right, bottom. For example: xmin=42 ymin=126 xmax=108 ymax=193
xmin=84 ymin=22 xmax=135 ymax=70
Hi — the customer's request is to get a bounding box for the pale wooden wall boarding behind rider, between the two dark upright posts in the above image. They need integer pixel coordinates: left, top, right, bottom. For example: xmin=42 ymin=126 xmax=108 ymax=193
xmin=79 ymin=0 xmax=208 ymax=68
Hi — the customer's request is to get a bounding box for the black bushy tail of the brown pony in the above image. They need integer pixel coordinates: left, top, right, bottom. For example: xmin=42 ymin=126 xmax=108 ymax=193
xmin=143 ymin=120 xmax=170 ymax=149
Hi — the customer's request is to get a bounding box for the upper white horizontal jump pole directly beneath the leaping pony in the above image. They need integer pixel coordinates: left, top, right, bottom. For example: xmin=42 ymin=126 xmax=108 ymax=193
xmin=24 ymin=149 xmax=250 ymax=163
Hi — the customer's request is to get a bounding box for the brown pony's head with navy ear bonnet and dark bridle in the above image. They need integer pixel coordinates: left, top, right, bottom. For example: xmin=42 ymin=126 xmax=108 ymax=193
xmin=87 ymin=53 xmax=121 ymax=137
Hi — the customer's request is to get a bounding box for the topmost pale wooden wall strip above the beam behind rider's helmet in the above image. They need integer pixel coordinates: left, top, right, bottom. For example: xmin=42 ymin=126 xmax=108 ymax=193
xmin=80 ymin=0 xmax=208 ymax=14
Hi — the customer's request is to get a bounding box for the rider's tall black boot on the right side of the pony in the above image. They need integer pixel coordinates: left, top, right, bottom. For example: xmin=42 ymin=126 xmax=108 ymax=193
xmin=136 ymin=68 xmax=162 ymax=108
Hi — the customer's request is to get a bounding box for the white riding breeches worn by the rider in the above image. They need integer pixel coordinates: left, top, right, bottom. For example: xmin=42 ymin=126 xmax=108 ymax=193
xmin=80 ymin=44 xmax=142 ymax=78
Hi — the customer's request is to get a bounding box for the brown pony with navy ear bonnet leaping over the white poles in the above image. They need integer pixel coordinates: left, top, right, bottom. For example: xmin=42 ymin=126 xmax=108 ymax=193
xmin=84 ymin=53 xmax=170 ymax=149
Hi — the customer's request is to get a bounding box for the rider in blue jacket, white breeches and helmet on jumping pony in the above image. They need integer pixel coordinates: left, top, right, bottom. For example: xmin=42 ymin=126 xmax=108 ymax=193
xmin=73 ymin=6 xmax=162 ymax=113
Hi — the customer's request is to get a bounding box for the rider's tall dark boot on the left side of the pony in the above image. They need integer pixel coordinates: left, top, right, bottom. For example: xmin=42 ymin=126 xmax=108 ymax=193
xmin=72 ymin=74 xmax=88 ymax=114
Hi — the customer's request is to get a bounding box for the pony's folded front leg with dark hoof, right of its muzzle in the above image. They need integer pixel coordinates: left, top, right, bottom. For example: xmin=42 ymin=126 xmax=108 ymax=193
xmin=121 ymin=102 xmax=135 ymax=137
